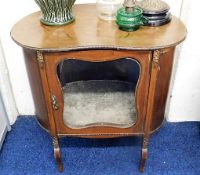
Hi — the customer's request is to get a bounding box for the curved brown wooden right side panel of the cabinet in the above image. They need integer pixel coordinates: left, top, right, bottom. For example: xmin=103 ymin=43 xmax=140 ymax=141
xmin=150 ymin=47 xmax=175 ymax=132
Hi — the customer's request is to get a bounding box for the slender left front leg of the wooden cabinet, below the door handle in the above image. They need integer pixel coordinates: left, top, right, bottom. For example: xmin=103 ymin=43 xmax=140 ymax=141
xmin=53 ymin=137 xmax=63 ymax=172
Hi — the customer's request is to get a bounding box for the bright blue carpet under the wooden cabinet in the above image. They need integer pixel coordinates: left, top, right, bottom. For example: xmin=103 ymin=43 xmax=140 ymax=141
xmin=0 ymin=117 xmax=200 ymax=175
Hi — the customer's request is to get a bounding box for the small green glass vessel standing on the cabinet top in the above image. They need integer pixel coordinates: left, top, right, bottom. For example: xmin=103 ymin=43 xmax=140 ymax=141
xmin=116 ymin=7 xmax=147 ymax=31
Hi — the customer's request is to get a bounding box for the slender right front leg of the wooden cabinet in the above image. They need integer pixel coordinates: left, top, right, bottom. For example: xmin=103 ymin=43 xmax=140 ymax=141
xmin=140 ymin=137 xmax=149 ymax=172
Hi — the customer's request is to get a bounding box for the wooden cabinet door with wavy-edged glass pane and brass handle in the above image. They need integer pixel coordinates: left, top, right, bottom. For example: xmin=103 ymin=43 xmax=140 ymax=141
xmin=44 ymin=50 xmax=151 ymax=136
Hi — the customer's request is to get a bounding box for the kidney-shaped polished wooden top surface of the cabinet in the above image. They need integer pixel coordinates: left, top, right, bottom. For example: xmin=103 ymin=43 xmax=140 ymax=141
xmin=11 ymin=4 xmax=187 ymax=51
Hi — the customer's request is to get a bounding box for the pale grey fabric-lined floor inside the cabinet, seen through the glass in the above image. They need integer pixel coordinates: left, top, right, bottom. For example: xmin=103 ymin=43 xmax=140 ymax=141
xmin=63 ymin=80 xmax=136 ymax=129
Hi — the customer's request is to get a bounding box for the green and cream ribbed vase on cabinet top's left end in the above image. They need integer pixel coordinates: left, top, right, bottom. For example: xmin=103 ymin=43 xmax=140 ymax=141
xmin=34 ymin=0 xmax=75 ymax=26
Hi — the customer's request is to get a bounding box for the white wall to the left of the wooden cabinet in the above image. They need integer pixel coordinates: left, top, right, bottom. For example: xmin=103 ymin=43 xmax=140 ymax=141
xmin=0 ymin=0 xmax=37 ymax=121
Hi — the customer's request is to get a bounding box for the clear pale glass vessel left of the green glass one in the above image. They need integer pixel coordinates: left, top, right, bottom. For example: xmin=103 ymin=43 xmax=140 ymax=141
xmin=96 ymin=0 xmax=124 ymax=20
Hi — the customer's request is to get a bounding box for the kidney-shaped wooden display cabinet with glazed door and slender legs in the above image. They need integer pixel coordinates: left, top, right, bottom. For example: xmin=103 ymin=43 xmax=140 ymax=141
xmin=11 ymin=4 xmax=186 ymax=171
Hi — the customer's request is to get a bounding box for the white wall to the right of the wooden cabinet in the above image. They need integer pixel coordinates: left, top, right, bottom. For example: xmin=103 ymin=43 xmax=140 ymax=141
xmin=168 ymin=0 xmax=200 ymax=122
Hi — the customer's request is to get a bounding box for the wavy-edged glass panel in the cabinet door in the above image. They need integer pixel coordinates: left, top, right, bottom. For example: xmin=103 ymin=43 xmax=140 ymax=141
xmin=57 ymin=58 xmax=140 ymax=128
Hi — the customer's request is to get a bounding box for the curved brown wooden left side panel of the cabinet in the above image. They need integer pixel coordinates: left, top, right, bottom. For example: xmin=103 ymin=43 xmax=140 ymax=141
xmin=23 ymin=49 xmax=49 ymax=130
